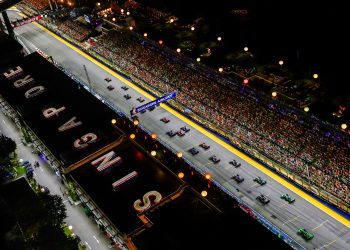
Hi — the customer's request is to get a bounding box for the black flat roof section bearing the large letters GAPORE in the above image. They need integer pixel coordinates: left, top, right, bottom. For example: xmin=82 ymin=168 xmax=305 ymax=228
xmin=0 ymin=53 xmax=120 ymax=167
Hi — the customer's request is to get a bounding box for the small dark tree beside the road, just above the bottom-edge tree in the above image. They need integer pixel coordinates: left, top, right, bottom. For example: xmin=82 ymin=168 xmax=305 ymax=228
xmin=39 ymin=193 xmax=67 ymax=226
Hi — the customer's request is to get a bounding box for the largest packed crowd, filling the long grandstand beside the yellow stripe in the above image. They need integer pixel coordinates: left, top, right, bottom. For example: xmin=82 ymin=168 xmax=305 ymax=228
xmin=91 ymin=30 xmax=350 ymax=203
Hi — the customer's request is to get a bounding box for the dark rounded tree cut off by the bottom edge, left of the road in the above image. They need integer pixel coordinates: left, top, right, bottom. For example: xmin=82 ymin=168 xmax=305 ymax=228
xmin=30 ymin=225 xmax=79 ymax=250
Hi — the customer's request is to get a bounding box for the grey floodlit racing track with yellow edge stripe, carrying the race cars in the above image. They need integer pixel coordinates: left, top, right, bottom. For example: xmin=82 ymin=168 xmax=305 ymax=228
xmin=3 ymin=8 xmax=350 ymax=250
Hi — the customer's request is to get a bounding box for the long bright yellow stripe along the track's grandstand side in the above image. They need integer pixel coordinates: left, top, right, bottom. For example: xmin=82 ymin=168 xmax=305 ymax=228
xmin=23 ymin=13 xmax=350 ymax=228
